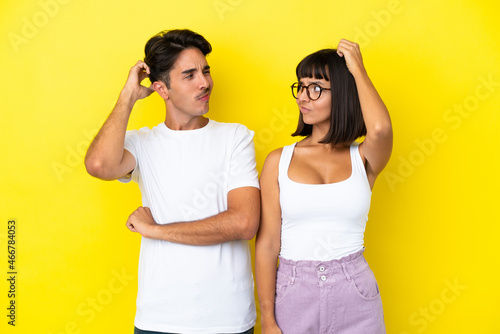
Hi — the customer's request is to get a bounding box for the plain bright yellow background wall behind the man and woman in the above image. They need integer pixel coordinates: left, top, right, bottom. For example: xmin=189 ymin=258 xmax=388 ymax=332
xmin=0 ymin=0 xmax=500 ymax=334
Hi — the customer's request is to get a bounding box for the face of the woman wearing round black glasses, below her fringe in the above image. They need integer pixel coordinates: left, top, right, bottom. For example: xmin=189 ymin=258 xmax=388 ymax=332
xmin=297 ymin=77 xmax=332 ymax=126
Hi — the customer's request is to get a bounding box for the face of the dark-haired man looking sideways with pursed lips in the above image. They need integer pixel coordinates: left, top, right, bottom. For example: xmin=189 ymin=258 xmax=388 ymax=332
xmin=167 ymin=48 xmax=213 ymax=117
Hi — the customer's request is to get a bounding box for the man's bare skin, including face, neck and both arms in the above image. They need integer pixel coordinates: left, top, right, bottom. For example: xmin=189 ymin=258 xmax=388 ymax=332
xmin=85 ymin=48 xmax=260 ymax=245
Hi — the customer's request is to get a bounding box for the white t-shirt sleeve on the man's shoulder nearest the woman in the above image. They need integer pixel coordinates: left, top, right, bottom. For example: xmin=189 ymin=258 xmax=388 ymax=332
xmin=228 ymin=125 xmax=259 ymax=191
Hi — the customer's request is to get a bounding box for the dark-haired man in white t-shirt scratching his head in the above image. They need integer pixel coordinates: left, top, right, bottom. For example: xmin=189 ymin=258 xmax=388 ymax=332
xmin=85 ymin=30 xmax=260 ymax=333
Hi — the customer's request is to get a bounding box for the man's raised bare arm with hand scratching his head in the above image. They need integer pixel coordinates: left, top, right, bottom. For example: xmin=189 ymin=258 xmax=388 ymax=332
xmin=85 ymin=61 xmax=154 ymax=180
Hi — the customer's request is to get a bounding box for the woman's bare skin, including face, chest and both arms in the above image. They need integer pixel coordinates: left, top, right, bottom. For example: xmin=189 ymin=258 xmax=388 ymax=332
xmin=255 ymin=39 xmax=392 ymax=334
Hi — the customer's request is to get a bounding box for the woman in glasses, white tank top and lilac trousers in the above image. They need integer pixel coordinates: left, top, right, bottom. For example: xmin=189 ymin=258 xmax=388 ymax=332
xmin=256 ymin=39 xmax=392 ymax=334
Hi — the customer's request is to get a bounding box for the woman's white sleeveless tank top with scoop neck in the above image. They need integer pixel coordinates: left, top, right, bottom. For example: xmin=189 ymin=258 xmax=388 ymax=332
xmin=278 ymin=142 xmax=371 ymax=261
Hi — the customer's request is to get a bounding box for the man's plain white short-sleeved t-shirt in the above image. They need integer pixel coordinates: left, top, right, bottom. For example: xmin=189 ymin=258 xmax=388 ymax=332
xmin=120 ymin=120 xmax=259 ymax=333
